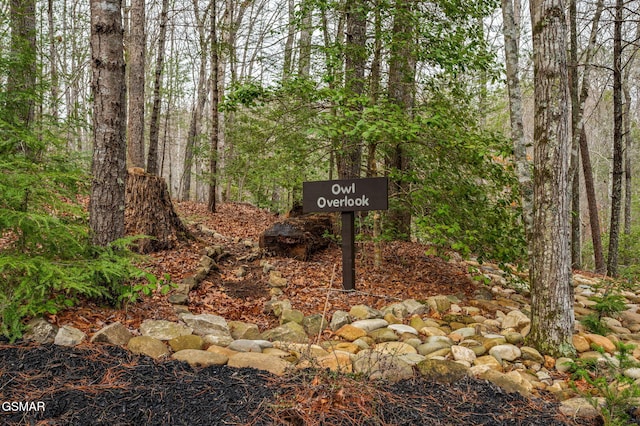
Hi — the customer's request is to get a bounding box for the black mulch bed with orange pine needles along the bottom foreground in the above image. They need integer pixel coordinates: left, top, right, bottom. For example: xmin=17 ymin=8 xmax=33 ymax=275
xmin=0 ymin=344 xmax=600 ymax=426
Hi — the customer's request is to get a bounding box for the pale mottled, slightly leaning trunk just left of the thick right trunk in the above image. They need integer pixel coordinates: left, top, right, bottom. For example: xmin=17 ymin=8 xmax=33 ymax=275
xmin=502 ymin=0 xmax=533 ymax=241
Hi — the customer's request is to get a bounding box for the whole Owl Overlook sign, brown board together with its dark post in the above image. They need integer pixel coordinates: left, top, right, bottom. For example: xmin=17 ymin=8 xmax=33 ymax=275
xmin=302 ymin=177 xmax=389 ymax=290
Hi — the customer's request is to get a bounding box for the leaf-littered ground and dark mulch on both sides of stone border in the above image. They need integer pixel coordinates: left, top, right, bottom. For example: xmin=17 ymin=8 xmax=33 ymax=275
xmin=0 ymin=202 xmax=598 ymax=425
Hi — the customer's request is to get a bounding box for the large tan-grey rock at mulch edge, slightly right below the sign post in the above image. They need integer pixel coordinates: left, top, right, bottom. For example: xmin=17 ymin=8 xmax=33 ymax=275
xmin=353 ymin=349 xmax=413 ymax=383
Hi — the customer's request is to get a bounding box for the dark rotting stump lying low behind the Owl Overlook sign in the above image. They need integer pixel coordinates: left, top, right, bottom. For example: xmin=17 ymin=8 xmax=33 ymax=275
xmin=260 ymin=214 xmax=334 ymax=260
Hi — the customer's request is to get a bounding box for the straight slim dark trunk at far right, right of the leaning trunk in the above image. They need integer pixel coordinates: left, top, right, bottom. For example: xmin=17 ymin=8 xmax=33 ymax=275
xmin=607 ymin=0 xmax=624 ymax=277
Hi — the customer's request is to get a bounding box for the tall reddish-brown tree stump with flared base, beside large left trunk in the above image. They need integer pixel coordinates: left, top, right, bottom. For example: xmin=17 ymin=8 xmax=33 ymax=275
xmin=125 ymin=167 xmax=193 ymax=253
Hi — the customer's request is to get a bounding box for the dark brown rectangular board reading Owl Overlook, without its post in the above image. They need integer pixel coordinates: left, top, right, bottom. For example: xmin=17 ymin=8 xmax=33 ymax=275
xmin=302 ymin=177 xmax=389 ymax=213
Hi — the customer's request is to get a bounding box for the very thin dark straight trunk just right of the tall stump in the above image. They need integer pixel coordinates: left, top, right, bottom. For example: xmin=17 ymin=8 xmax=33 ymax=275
xmin=208 ymin=0 xmax=219 ymax=213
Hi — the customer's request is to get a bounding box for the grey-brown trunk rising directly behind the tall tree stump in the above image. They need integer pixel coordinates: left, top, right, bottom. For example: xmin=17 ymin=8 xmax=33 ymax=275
xmin=127 ymin=0 xmax=147 ymax=169
